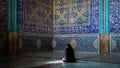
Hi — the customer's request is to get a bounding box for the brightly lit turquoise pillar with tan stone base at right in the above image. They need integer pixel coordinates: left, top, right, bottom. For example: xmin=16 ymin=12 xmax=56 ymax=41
xmin=100 ymin=0 xmax=110 ymax=55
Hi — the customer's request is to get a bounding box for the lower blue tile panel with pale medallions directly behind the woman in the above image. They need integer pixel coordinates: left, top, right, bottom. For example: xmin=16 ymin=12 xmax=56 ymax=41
xmin=54 ymin=35 xmax=99 ymax=52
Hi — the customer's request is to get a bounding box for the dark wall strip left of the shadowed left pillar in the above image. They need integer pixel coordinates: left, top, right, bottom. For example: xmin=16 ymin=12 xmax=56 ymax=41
xmin=0 ymin=0 xmax=7 ymax=54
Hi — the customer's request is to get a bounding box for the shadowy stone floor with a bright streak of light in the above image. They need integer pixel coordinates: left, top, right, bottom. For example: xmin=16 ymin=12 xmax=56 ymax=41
xmin=0 ymin=52 xmax=120 ymax=68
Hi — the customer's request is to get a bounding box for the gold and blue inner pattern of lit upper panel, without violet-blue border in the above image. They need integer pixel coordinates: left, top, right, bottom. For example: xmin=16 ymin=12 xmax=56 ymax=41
xmin=54 ymin=0 xmax=90 ymax=26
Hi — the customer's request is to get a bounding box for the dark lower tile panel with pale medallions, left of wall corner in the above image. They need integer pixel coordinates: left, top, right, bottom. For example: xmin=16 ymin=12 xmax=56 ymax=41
xmin=17 ymin=36 xmax=52 ymax=52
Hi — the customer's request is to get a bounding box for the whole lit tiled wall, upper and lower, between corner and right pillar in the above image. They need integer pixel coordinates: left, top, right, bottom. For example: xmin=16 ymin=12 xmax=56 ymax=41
xmin=53 ymin=0 xmax=99 ymax=52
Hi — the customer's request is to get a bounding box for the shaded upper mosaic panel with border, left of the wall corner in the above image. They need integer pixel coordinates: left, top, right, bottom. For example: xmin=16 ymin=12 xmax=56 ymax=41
xmin=18 ymin=0 xmax=53 ymax=34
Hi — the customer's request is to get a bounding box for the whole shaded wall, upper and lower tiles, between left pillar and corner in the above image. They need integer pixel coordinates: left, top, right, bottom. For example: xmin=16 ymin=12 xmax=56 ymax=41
xmin=17 ymin=0 xmax=53 ymax=52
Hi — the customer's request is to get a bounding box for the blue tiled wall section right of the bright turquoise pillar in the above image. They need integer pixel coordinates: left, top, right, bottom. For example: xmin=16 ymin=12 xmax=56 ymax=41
xmin=109 ymin=0 xmax=120 ymax=53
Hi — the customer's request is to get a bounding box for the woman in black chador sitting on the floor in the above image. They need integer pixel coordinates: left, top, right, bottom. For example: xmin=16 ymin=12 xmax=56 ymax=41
xmin=63 ymin=44 xmax=76 ymax=62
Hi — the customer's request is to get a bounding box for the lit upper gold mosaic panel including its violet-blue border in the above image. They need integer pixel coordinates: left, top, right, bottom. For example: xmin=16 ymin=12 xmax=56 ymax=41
xmin=53 ymin=0 xmax=99 ymax=34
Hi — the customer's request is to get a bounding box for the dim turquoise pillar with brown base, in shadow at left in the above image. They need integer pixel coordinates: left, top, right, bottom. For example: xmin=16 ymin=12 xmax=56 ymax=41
xmin=7 ymin=0 xmax=17 ymax=56
